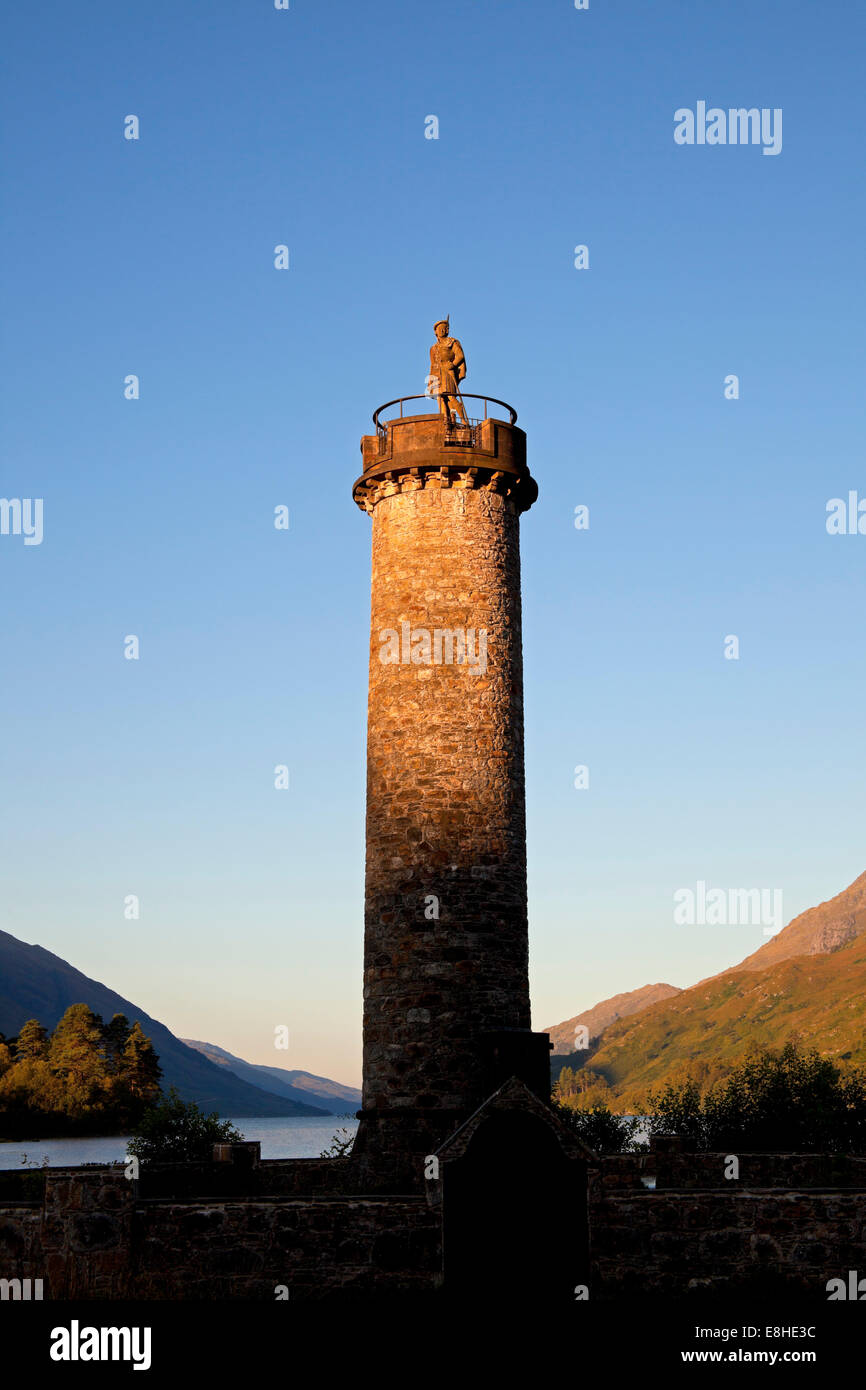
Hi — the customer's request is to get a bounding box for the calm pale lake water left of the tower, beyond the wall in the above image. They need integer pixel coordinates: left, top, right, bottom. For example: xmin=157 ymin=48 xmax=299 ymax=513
xmin=0 ymin=1115 xmax=357 ymax=1168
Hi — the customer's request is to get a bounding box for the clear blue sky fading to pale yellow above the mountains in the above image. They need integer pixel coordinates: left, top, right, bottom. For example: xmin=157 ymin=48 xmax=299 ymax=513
xmin=0 ymin=0 xmax=866 ymax=1081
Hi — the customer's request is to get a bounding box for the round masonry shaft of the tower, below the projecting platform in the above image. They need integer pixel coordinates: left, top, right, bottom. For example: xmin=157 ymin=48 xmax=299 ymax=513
xmin=364 ymin=488 xmax=530 ymax=1109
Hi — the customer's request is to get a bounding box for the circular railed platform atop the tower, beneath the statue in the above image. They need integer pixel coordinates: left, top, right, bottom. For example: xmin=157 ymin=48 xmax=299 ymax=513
xmin=352 ymin=393 xmax=538 ymax=512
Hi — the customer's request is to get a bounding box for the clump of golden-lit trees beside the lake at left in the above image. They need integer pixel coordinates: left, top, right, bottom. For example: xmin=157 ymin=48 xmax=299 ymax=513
xmin=0 ymin=1004 xmax=163 ymax=1138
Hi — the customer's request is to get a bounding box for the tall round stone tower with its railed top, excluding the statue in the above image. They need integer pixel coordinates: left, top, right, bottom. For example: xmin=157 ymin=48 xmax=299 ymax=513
xmin=353 ymin=396 xmax=549 ymax=1182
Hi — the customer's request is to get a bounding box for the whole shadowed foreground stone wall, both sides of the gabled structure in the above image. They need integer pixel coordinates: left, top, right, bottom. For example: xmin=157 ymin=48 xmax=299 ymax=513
xmin=0 ymin=1154 xmax=866 ymax=1301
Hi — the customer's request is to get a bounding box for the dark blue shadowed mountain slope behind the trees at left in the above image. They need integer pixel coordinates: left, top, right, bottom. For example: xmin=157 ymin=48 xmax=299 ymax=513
xmin=0 ymin=931 xmax=329 ymax=1119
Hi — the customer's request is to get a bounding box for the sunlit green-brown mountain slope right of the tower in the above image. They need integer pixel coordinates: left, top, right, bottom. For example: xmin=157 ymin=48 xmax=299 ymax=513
xmin=560 ymin=874 xmax=866 ymax=1111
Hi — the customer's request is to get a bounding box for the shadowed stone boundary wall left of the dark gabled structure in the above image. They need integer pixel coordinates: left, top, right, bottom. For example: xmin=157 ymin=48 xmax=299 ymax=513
xmin=0 ymin=1161 xmax=441 ymax=1301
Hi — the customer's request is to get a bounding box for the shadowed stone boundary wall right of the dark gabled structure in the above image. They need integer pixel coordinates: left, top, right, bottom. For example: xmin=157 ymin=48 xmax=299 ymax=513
xmin=588 ymin=1154 xmax=866 ymax=1300
